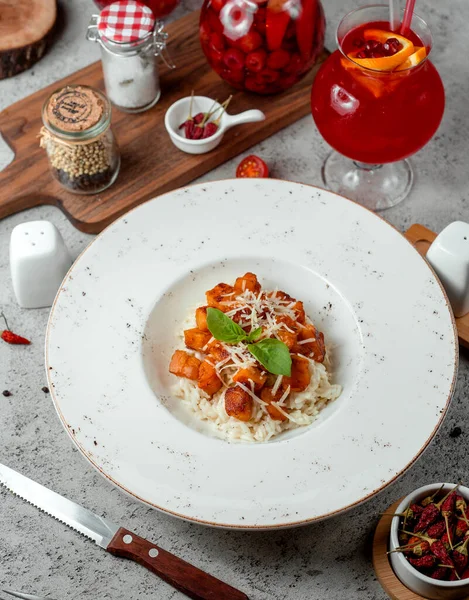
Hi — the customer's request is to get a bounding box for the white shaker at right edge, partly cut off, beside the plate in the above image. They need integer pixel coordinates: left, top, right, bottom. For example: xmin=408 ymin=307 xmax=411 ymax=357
xmin=427 ymin=221 xmax=469 ymax=317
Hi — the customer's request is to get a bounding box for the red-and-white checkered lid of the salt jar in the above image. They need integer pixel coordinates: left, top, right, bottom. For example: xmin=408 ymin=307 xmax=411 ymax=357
xmin=98 ymin=0 xmax=155 ymax=44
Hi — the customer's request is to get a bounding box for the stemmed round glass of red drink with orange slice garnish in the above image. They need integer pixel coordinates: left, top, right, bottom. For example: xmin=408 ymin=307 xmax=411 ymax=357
xmin=311 ymin=5 xmax=445 ymax=210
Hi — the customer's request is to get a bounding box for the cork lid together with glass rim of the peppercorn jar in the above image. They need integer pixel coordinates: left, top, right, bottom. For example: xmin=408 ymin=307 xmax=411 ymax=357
xmin=42 ymin=85 xmax=111 ymax=142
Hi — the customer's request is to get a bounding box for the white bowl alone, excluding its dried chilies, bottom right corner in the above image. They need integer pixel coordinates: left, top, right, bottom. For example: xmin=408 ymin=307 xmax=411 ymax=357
xmin=389 ymin=483 xmax=469 ymax=600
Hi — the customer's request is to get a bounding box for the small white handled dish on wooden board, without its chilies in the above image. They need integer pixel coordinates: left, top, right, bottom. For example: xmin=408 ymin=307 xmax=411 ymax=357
xmin=164 ymin=96 xmax=265 ymax=154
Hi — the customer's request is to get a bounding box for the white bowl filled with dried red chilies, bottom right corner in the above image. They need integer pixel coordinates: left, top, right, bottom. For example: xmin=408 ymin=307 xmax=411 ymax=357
xmin=389 ymin=483 xmax=469 ymax=600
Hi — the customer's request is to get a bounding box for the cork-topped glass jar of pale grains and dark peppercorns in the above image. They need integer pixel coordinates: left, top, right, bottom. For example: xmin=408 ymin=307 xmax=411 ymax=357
xmin=41 ymin=85 xmax=120 ymax=194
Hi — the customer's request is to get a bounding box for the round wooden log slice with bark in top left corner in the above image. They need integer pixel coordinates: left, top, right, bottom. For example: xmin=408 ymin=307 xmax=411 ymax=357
xmin=0 ymin=0 xmax=57 ymax=79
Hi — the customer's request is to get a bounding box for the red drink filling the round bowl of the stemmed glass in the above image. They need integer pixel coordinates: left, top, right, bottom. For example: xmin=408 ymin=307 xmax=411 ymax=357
xmin=311 ymin=21 xmax=445 ymax=165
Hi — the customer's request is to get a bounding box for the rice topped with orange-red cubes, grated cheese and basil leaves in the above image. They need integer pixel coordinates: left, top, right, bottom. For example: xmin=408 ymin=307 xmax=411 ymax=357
xmin=169 ymin=273 xmax=342 ymax=442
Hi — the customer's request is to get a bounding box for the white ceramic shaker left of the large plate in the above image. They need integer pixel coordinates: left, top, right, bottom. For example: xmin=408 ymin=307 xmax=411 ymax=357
xmin=10 ymin=221 xmax=72 ymax=308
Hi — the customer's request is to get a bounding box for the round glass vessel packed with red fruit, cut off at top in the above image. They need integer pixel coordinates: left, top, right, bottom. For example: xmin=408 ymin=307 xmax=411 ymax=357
xmin=200 ymin=0 xmax=325 ymax=94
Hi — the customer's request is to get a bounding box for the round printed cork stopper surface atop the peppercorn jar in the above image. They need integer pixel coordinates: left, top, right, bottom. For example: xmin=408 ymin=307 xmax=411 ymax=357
xmin=47 ymin=86 xmax=104 ymax=131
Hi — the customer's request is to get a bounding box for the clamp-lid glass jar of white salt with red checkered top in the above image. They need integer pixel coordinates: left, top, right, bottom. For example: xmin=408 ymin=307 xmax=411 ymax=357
xmin=86 ymin=0 xmax=174 ymax=113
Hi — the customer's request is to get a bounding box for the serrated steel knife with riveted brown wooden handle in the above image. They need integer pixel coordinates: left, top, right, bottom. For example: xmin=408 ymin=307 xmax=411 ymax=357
xmin=0 ymin=463 xmax=249 ymax=600
